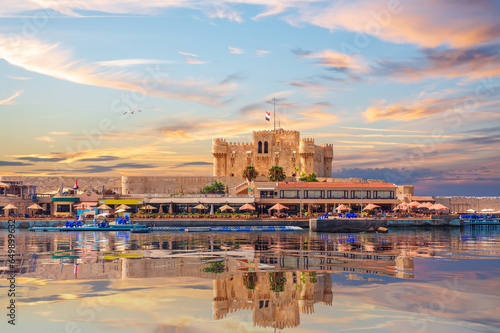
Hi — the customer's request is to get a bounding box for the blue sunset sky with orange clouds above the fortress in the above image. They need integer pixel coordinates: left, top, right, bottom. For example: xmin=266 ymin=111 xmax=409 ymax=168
xmin=0 ymin=0 xmax=500 ymax=196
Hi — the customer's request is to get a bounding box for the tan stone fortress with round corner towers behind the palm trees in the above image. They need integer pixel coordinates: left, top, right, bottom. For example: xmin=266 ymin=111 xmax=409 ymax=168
xmin=212 ymin=129 xmax=333 ymax=177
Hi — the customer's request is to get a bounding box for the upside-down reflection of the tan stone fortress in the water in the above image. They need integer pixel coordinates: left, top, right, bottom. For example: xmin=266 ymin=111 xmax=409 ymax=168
xmin=213 ymin=271 xmax=333 ymax=329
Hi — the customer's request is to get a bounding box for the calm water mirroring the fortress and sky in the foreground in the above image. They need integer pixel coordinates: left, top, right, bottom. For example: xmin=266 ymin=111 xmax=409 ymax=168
xmin=0 ymin=226 xmax=500 ymax=333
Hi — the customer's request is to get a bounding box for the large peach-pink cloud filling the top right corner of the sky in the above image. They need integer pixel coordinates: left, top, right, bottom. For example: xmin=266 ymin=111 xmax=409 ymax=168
xmin=287 ymin=0 xmax=500 ymax=49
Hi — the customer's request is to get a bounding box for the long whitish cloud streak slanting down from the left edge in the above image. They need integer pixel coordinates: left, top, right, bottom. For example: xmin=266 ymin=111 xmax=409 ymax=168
xmin=0 ymin=35 xmax=236 ymax=106
